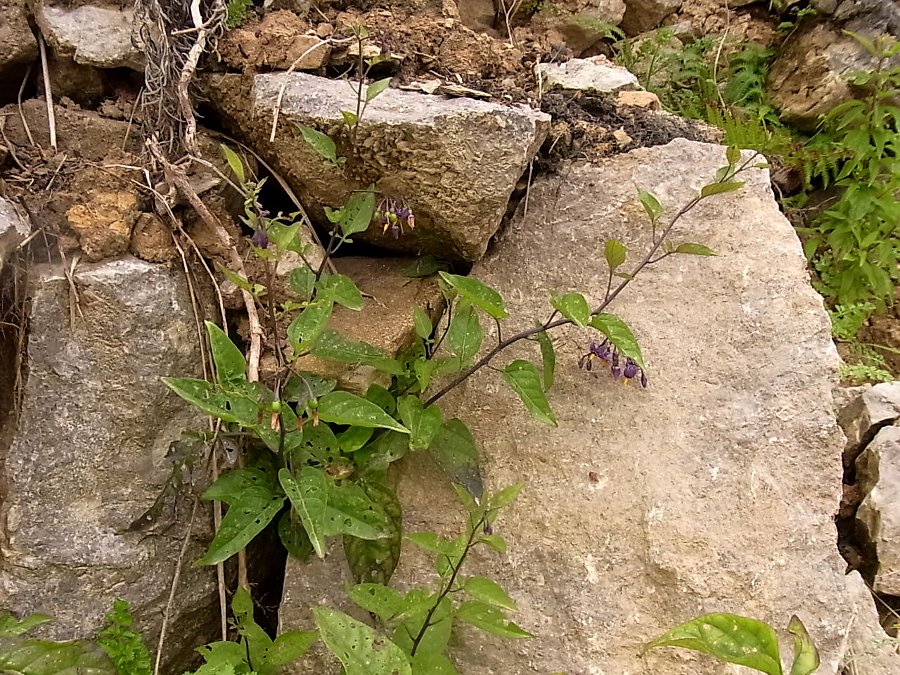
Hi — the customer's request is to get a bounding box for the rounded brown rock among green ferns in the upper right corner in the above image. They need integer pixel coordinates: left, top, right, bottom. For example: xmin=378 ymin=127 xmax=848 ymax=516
xmin=767 ymin=21 xmax=900 ymax=129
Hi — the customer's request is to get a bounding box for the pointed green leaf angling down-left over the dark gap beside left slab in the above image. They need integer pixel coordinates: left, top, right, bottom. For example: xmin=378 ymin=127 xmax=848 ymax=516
xmin=194 ymin=486 xmax=284 ymax=567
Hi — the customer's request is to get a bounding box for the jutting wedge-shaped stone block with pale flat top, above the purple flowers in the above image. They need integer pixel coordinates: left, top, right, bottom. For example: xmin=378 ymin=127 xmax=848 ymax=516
xmin=208 ymin=73 xmax=550 ymax=260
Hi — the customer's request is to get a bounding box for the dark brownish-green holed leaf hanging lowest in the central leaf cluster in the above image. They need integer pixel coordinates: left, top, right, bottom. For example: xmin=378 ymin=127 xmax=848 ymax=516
xmin=344 ymin=480 xmax=403 ymax=584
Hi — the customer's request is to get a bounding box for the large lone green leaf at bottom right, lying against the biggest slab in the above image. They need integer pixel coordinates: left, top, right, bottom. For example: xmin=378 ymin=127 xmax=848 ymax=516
xmin=643 ymin=614 xmax=782 ymax=675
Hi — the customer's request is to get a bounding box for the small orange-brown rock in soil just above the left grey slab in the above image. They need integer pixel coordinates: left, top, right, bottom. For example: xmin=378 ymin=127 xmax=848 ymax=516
xmin=66 ymin=190 xmax=138 ymax=262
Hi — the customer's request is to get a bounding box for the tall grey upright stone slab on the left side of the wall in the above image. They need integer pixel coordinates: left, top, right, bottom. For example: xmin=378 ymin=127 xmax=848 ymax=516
xmin=0 ymin=258 xmax=217 ymax=672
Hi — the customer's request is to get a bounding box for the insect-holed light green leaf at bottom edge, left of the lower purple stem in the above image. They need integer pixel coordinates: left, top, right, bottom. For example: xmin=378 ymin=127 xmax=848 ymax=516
xmin=312 ymin=606 xmax=412 ymax=675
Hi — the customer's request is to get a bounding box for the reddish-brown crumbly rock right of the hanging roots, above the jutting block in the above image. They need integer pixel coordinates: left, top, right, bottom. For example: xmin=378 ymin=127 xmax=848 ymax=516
xmin=219 ymin=10 xmax=331 ymax=70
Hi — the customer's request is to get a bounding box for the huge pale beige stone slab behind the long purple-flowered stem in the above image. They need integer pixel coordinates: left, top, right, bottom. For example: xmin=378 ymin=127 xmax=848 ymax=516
xmin=395 ymin=140 xmax=850 ymax=675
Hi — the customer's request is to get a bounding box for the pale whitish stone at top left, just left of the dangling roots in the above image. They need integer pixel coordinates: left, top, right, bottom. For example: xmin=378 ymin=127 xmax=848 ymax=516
xmin=35 ymin=2 xmax=144 ymax=71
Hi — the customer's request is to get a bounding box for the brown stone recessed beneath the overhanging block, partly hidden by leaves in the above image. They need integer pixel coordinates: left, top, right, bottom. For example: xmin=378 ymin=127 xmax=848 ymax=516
xmin=298 ymin=257 xmax=444 ymax=394
